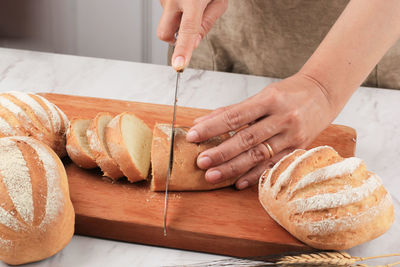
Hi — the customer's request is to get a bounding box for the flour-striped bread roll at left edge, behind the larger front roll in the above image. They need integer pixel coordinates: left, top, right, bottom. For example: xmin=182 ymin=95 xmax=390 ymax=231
xmin=0 ymin=91 xmax=69 ymax=157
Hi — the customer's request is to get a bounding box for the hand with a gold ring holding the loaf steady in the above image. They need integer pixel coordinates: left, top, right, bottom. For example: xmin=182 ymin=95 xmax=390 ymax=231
xmin=187 ymin=74 xmax=340 ymax=189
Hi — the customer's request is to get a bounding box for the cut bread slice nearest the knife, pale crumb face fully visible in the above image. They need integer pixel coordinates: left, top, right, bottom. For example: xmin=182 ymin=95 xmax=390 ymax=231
xmin=106 ymin=112 xmax=152 ymax=182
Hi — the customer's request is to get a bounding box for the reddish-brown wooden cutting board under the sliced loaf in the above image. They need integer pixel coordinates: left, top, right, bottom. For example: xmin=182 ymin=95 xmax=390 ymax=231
xmin=42 ymin=94 xmax=356 ymax=257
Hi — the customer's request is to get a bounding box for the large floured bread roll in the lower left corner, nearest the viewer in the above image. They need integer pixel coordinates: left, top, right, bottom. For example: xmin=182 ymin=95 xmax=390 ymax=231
xmin=0 ymin=136 xmax=75 ymax=265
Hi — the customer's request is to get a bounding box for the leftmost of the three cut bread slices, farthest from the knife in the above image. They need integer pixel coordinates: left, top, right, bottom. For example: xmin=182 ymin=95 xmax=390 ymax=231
xmin=66 ymin=119 xmax=97 ymax=169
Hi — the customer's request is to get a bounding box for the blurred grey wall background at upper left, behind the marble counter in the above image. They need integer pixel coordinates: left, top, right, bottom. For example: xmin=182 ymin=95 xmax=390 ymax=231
xmin=0 ymin=0 xmax=168 ymax=65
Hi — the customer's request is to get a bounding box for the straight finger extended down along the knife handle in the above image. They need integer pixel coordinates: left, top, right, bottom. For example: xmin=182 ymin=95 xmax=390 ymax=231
xmin=171 ymin=8 xmax=204 ymax=71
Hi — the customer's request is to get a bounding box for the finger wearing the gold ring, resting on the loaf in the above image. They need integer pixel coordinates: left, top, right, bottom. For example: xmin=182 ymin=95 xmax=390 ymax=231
xmin=206 ymin=144 xmax=270 ymax=183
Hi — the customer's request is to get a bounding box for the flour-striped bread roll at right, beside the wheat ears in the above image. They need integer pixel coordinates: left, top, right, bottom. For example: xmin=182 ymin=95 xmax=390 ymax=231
xmin=259 ymin=146 xmax=394 ymax=250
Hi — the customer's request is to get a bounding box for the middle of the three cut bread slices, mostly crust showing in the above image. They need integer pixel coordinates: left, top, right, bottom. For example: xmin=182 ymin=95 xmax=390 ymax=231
xmin=86 ymin=112 xmax=124 ymax=180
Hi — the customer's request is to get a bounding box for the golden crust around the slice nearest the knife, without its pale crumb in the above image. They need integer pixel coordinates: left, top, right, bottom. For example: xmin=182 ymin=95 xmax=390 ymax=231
xmin=105 ymin=112 xmax=150 ymax=183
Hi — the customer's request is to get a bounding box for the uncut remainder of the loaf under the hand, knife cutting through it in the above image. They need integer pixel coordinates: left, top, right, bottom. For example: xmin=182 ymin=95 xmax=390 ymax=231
xmin=151 ymin=124 xmax=236 ymax=191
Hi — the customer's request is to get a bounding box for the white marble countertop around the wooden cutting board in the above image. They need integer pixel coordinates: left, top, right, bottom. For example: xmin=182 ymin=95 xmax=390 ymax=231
xmin=0 ymin=48 xmax=400 ymax=266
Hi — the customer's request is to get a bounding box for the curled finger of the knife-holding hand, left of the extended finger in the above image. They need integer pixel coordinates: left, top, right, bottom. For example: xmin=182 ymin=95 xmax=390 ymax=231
xmin=157 ymin=1 xmax=182 ymax=44
